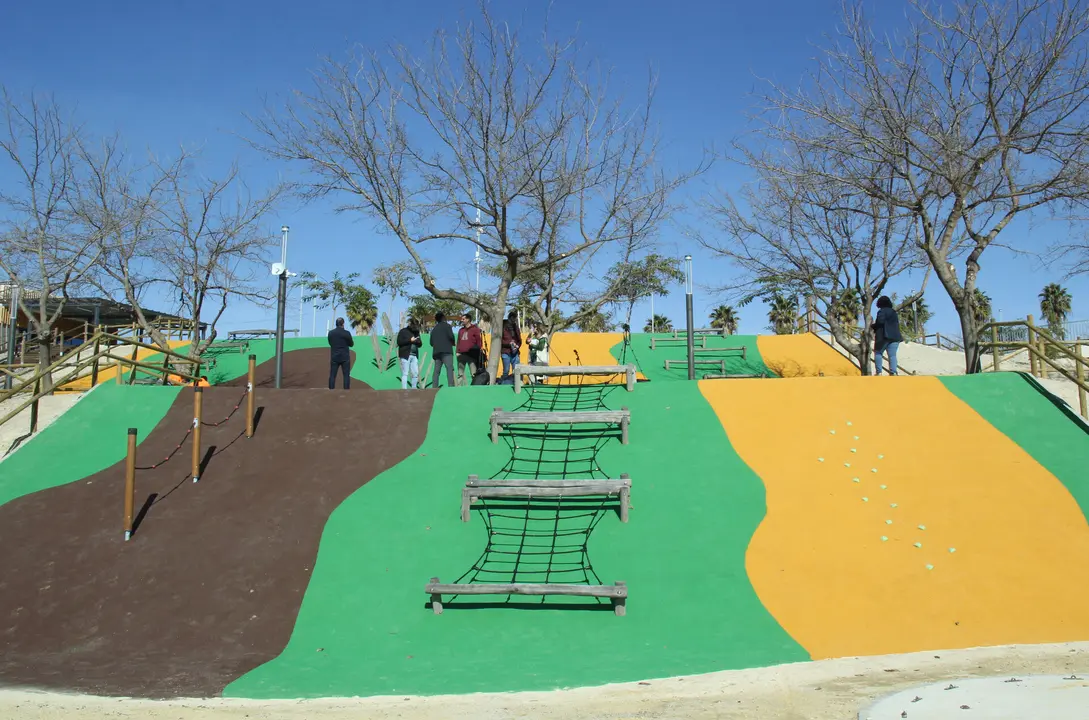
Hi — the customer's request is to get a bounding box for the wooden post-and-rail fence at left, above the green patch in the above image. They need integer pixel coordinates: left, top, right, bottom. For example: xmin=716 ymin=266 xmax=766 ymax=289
xmin=0 ymin=331 xmax=203 ymax=453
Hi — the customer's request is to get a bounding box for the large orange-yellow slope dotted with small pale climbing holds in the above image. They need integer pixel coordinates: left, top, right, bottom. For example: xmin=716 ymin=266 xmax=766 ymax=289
xmin=700 ymin=376 xmax=1089 ymax=659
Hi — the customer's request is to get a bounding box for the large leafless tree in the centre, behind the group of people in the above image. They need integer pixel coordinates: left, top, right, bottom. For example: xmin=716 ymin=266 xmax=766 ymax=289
xmin=254 ymin=7 xmax=687 ymax=377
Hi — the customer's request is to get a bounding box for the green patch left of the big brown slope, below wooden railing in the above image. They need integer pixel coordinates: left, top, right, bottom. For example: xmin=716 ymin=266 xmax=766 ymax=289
xmin=0 ymin=385 xmax=181 ymax=505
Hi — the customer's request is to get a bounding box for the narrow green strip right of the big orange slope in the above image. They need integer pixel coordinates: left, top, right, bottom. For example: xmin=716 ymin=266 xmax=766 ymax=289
xmin=941 ymin=373 xmax=1089 ymax=518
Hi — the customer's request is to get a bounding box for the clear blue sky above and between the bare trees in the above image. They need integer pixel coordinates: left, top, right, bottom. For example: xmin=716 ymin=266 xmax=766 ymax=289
xmin=0 ymin=0 xmax=1089 ymax=333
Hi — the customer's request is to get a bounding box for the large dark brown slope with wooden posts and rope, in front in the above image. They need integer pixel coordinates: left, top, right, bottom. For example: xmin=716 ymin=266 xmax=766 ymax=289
xmin=0 ymin=388 xmax=435 ymax=697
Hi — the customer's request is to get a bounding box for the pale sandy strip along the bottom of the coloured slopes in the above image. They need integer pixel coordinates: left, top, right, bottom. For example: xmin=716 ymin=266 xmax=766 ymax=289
xmin=0 ymin=643 xmax=1089 ymax=720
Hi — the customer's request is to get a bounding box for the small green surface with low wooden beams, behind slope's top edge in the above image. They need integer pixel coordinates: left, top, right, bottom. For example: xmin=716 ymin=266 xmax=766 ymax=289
xmin=609 ymin=333 xmax=774 ymax=380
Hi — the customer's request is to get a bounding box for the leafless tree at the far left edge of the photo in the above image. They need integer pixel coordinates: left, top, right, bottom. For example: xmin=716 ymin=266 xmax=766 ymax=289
xmin=0 ymin=89 xmax=99 ymax=390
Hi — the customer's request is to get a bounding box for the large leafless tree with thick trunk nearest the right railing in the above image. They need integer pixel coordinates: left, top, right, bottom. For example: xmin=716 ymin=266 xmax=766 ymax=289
xmin=753 ymin=0 xmax=1089 ymax=373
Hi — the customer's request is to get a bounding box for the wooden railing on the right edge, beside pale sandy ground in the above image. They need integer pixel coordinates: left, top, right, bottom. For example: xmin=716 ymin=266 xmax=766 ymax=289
xmin=979 ymin=315 xmax=1089 ymax=419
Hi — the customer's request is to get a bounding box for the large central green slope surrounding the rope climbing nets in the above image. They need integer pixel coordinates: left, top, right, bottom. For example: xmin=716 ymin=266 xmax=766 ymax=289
xmin=224 ymin=383 xmax=808 ymax=698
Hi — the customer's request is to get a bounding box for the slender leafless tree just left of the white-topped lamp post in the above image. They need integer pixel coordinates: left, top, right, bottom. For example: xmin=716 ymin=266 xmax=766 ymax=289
xmin=151 ymin=159 xmax=282 ymax=357
